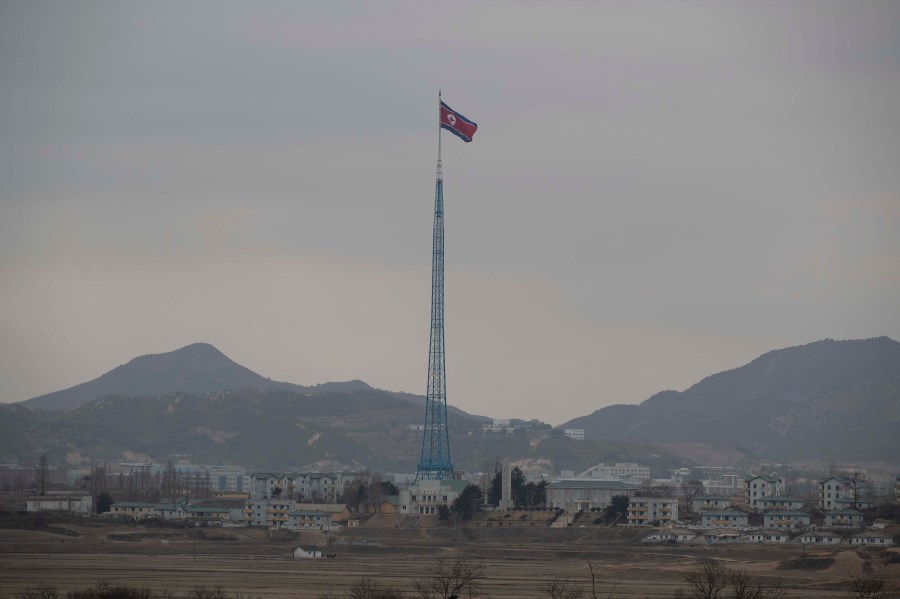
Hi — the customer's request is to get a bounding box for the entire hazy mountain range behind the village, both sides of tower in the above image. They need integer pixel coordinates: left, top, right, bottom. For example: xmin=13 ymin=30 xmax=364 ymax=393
xmin=0 ymin=337 xmax=900 ymax=471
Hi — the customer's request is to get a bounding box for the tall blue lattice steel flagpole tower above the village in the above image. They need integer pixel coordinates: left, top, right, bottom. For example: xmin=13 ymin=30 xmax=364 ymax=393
xmin=416 ymin=98 xmax=453 ymax=480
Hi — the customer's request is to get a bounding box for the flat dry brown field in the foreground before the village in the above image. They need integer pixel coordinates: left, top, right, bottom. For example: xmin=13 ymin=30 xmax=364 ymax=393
xmin=0 ymin=524 xmax=900 ymax=599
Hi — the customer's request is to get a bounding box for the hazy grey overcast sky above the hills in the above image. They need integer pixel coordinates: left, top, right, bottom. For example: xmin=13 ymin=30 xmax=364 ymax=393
xmin=0 ymin=0 xmax=900 ymax=424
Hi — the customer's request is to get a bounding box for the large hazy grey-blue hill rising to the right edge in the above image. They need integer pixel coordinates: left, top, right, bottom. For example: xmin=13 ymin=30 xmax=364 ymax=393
xmin=561 ymin=337 xmax=900 ymax=462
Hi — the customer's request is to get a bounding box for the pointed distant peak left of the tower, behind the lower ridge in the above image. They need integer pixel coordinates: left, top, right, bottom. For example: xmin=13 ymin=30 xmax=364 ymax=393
xmin=21 ymin=343 xmax=370 ymax=410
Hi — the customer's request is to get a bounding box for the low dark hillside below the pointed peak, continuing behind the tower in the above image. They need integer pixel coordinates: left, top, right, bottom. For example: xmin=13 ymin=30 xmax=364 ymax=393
xmin=0 ymin=389 xmax=683 ymax=473
